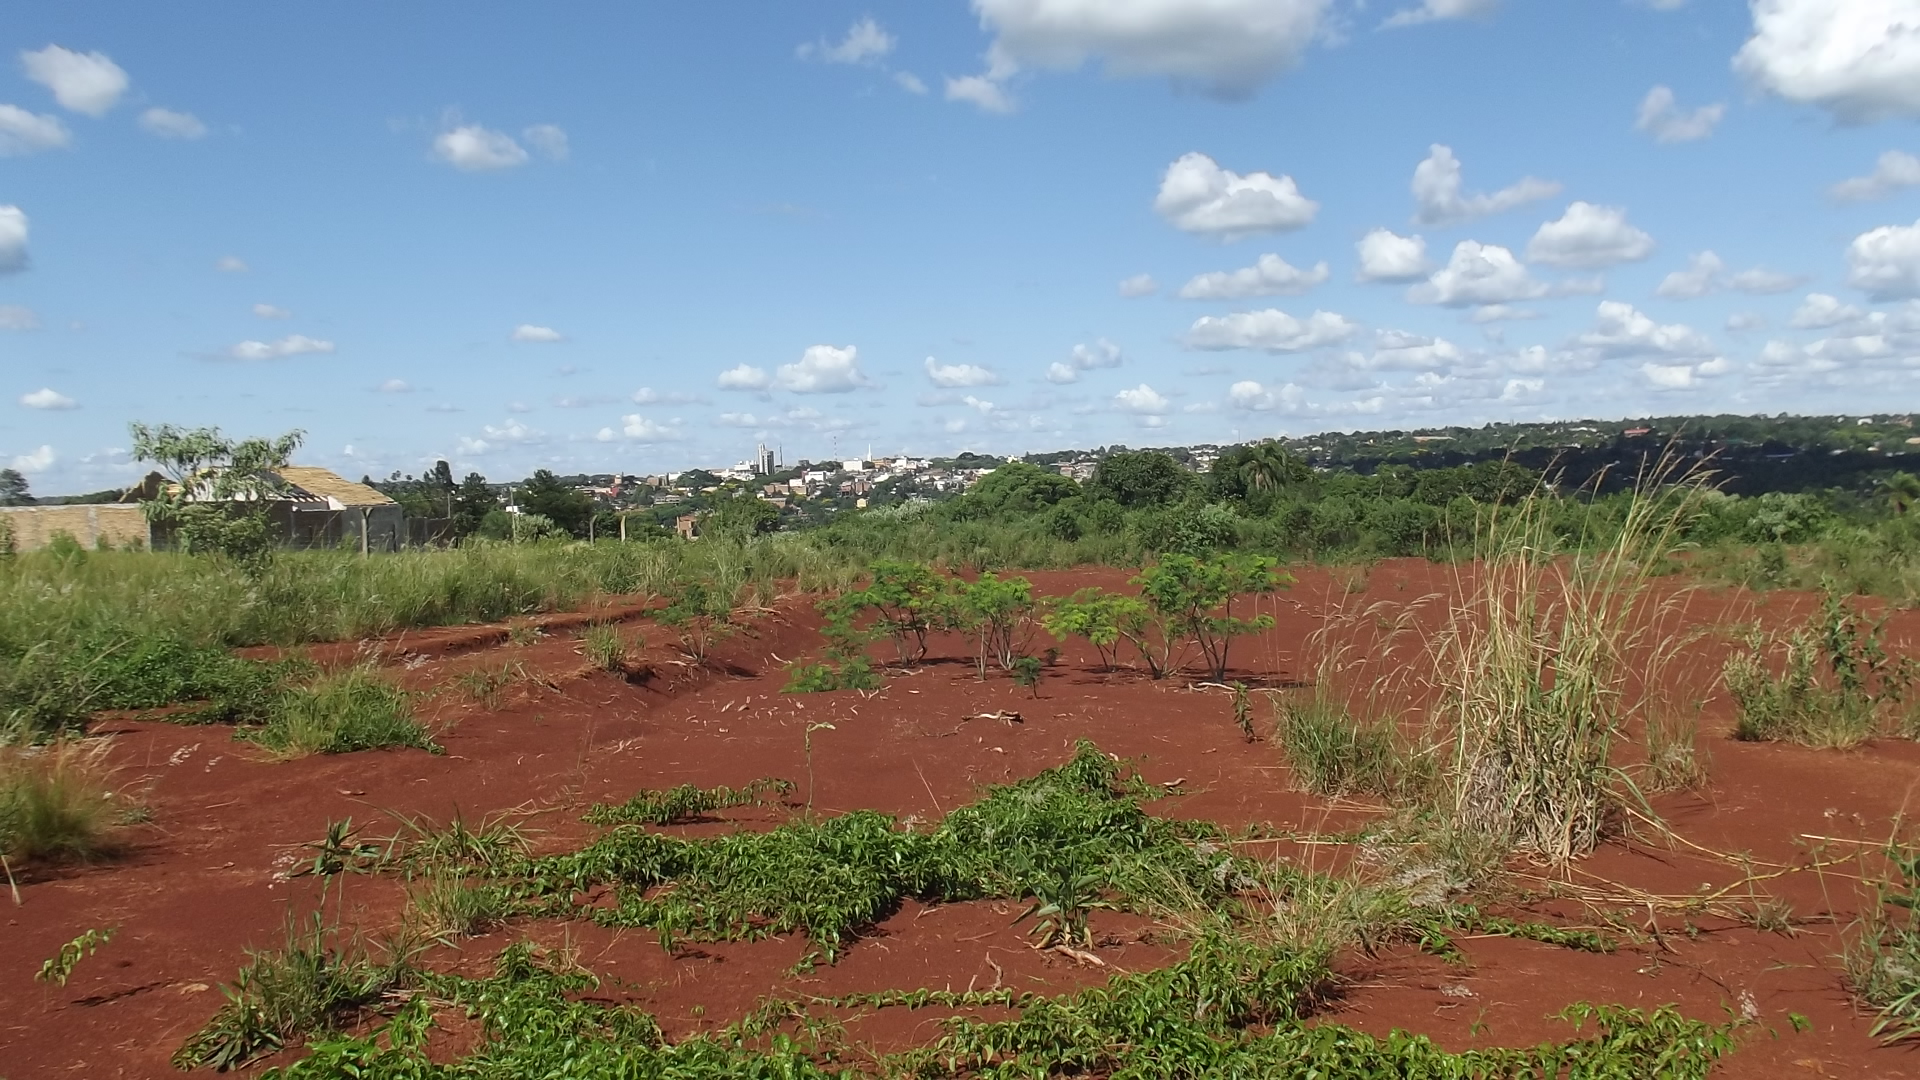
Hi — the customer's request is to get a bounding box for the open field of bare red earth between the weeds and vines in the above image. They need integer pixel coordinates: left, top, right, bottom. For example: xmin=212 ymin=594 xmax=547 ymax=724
xmin=0 ymin=561 xmax=1920 ymax=1080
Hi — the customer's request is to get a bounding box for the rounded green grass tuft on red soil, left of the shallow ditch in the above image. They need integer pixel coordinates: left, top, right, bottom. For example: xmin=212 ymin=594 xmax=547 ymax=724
xmin=240 ymin=665 xmax=440 ymax=757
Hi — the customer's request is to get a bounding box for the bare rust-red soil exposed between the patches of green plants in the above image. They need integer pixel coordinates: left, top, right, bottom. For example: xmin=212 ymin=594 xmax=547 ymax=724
xmin=11 ymin=561 xmax=1920 ymax=1080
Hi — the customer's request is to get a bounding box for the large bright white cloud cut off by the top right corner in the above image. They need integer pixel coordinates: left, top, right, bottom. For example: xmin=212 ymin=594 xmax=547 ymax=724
xmin=1734 ymin=0 xmax=1920 ymax=123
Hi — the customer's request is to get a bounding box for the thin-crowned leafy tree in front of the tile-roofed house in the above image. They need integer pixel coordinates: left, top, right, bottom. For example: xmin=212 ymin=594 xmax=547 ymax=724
xmin=127 ymin=423 xmax=305 ymax=573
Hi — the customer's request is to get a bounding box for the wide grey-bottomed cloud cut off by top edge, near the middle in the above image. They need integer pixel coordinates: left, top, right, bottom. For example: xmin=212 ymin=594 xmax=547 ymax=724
xmin=973 ymin=0 xmax=1332 ymax=98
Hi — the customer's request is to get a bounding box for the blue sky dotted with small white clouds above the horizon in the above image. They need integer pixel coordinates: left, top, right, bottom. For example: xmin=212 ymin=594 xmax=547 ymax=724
xmin=0 ymin=0 xmax=1920 ymax=492
